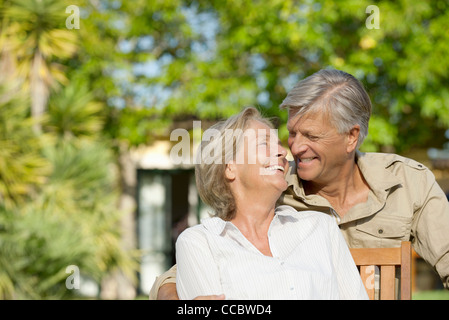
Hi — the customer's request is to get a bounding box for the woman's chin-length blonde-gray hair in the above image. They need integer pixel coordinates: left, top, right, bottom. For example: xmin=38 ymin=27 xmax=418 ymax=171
xmin=195 ymin=107 xmax=273 ymax=221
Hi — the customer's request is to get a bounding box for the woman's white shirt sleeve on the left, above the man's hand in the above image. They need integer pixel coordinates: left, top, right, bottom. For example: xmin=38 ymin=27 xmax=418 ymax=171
xmin=176 ymin=226 xmax=224 ymax=300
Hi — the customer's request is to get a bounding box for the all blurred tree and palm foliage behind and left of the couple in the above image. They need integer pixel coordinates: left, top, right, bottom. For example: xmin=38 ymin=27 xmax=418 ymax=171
xmin=0 ymin=0 xmax=449 ymax=298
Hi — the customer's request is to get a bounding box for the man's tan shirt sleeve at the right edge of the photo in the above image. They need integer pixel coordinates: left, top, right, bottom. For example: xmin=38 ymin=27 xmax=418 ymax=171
xmin=412 ymin=170 xmax=449 ymax=289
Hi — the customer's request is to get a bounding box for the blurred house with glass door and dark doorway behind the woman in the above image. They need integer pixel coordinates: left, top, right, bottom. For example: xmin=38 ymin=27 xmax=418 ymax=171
xmin=130 ymin=140 xmax=212 ymax=295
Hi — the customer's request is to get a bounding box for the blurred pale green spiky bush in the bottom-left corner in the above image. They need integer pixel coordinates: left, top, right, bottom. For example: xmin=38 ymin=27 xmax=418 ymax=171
xmin=0 ymin=202 xmax=98 ymax=299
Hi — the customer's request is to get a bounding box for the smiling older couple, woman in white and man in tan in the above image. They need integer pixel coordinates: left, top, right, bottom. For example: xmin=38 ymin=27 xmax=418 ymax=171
xmin=150 ymin=69 xmax=449 ymax=300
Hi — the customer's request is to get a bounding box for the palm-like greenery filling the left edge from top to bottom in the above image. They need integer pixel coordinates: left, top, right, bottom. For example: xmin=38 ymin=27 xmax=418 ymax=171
xmin=0 ymin=0 xmax=137 ymax=298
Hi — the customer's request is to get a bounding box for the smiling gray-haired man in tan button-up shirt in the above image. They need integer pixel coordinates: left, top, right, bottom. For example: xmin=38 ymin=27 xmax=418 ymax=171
xmin=150 ymin=69 xmax=449 ymax=299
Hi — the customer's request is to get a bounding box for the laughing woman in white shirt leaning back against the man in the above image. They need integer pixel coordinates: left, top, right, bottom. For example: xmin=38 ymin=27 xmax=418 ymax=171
xmin=172 ymin=107 xmax=367 ymax=299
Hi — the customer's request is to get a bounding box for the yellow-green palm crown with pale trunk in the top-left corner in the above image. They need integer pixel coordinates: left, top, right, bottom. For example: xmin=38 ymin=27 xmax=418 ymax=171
xmin=1 ymin=0 xmax=77 ymax=129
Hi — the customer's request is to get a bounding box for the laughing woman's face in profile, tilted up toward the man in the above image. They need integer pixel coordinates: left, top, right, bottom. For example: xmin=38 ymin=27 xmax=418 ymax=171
xmin=235 ymin=120 xmax=288 ymax=195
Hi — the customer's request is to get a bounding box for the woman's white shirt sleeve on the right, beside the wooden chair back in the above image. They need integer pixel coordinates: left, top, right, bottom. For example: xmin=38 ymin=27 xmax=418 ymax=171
xmin=328 ymin=218 xmax=368 ymax=300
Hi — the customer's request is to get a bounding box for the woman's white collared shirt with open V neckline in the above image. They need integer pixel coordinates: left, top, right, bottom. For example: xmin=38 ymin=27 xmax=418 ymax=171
xmin=176 ymin=205 xmax=368 ymax=300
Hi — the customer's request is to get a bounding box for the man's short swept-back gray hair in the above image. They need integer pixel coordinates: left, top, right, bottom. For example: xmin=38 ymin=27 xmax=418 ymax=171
xmin=280 ymin=69 xmax=371 ymax=148
